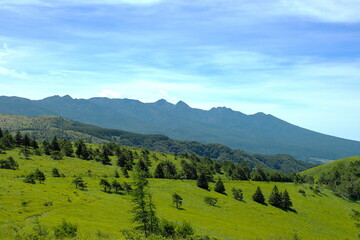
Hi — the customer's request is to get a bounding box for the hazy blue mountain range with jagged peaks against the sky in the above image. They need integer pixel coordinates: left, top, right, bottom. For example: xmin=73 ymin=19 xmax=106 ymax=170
xmin=0 ymin=96 xmax=360 ymax=162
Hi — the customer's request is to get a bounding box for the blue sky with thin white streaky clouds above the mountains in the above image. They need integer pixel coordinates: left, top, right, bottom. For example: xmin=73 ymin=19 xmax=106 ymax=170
xmin=0 ymin=0 xmax=360 ymax=140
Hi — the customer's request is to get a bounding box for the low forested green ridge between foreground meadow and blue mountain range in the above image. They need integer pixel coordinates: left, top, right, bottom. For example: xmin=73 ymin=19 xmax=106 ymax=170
xmin=0 ymin=114 xmax=315 ymax=172
